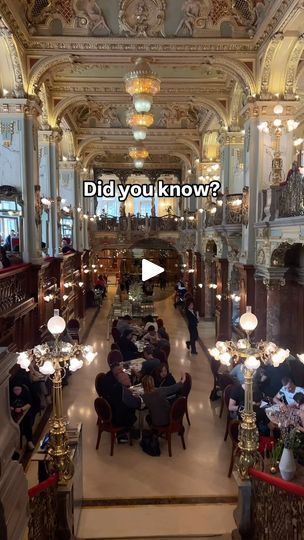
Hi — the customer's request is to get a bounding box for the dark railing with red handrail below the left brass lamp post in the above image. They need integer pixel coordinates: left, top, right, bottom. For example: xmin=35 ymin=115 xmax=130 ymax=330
xmin=28 ymin=475 xmax=58 ymax=540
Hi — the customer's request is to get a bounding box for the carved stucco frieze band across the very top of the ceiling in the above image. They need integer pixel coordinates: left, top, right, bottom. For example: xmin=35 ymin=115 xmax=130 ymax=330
xmin=20 ymin=0 xmax=270 ymax=38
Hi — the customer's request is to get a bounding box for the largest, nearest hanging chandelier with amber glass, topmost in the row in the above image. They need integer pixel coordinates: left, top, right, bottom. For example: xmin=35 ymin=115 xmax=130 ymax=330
xmin=124 ymin=58 xmax=160 ymax=113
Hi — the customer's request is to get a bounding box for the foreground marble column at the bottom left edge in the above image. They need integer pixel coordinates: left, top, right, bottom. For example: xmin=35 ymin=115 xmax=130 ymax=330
xmin=0 ymin=348 xmax=28 ymax=540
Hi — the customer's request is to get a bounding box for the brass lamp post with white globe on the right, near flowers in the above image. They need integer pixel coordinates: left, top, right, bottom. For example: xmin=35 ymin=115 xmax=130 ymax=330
xmin=209 ymin=306 xmax=289 ymax=480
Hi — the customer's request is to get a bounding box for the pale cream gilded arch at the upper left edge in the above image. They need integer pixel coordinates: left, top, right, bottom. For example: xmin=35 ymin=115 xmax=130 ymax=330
xmin=0 ymin=19 xmax=25 ymax=98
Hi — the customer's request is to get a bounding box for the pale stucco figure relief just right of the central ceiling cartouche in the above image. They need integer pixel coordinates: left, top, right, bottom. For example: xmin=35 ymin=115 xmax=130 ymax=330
xmin=175 ymin=0 xmax=212 ymax=36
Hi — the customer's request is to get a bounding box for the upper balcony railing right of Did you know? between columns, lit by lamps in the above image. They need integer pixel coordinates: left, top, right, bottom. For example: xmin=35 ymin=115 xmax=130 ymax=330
xmin=206 ymin=189 xmax=248 ymax=227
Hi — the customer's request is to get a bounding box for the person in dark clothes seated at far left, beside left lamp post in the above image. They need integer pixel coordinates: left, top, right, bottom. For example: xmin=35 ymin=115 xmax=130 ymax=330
xmin=10 ymin=380 xmax=35 ymax=450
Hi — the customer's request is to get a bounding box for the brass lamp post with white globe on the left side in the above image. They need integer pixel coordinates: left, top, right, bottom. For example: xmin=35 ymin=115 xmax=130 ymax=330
xmin=17 ymin=309 xmax=97 ymax=483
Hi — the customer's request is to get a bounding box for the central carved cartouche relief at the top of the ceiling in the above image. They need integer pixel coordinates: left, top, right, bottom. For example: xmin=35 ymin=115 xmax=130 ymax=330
xmin=118 ymin=0 xmax=167 ymax=37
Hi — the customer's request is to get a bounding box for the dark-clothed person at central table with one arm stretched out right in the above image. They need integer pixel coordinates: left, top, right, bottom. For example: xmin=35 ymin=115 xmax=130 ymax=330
xmin=142 ymin=375 xmax=186 ymax=426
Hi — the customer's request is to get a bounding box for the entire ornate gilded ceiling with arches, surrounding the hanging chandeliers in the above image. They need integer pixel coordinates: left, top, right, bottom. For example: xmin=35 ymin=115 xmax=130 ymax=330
xmin=0 ymin=0 xmax=304 ymax=169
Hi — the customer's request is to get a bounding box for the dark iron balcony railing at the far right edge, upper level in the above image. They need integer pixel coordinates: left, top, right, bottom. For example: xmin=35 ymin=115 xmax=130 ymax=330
xmin=260 ymin=170 xmax=304 ymax=221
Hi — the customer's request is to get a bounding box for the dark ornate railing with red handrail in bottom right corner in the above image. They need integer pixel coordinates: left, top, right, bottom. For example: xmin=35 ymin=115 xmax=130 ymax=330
xmin=249 ymin=469 xmax=304 ymax=540
